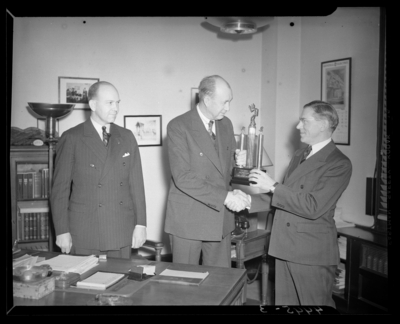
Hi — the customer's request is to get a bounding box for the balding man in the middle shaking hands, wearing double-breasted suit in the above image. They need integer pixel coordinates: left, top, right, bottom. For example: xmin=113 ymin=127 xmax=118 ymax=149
xmin=165 ymin=76 xmax=249 ymax=267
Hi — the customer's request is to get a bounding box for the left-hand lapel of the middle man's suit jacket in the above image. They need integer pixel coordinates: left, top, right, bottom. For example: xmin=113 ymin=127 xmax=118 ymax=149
xmin=190 ymin=109 xmax=223 ymax=175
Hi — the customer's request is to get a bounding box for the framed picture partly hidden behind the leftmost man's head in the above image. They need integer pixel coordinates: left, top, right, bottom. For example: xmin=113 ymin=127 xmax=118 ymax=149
xmin=58 ymin=76 xmax=100 ymax=110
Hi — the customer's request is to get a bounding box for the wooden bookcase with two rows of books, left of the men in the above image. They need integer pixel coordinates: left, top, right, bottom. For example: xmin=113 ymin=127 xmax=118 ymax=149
xmin=10 ymin=145 xmax=54 ymax=251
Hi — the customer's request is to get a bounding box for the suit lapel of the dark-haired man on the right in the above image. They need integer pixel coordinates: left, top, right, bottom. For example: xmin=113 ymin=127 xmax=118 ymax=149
xmin=284 ymin=142 xmax=336 ymax=185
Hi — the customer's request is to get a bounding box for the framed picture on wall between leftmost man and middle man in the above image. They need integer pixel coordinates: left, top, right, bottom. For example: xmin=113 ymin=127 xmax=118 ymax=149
xmin=124 ymin=115 xmax=162 ymax=146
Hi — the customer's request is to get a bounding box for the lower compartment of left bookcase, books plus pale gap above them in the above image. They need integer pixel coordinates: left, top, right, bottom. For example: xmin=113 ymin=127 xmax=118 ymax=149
xmin=17 ymin=200 xmax=49 ymax=241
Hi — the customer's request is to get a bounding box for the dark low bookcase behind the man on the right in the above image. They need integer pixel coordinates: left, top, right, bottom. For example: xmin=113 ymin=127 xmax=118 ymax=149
xmin=333 ymin=227 xmax=390 ymax=314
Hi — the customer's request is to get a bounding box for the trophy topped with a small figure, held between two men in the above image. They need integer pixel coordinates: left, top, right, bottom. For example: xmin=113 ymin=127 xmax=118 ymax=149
xmin=232 ymin=104 xmax=272 ymax=186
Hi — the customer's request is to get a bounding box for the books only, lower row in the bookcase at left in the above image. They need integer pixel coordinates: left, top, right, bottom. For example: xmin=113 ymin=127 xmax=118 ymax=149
xmin=17 ymin=212 xmax=49 ymax=242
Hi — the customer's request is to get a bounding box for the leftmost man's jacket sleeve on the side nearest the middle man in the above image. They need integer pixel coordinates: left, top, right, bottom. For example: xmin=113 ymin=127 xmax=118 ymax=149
xmin=129 ymin=132 xmax=147 ymax=226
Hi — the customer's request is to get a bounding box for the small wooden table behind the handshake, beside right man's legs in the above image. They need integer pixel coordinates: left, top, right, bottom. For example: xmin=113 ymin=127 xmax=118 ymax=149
xmin=232 ymin=229 xmax=271 ymax=305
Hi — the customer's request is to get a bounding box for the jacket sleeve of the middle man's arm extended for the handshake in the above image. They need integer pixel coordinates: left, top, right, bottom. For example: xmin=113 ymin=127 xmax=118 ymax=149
xmin=167 ymin=121 xmax=228 ymax=211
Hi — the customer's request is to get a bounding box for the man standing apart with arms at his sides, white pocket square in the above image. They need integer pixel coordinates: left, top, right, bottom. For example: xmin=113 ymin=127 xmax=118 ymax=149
xmin=50 ymin=81 xmax=146 ymax=258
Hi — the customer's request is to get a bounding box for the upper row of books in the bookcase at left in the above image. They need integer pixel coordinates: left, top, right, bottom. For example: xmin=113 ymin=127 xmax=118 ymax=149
xmin=17 ymin=168 xmax=49 ymax=199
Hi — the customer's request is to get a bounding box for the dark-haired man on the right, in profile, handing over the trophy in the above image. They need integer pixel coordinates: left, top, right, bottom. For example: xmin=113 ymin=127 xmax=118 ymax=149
xmin=250 ymin=101 xmax=352 ymax=307
